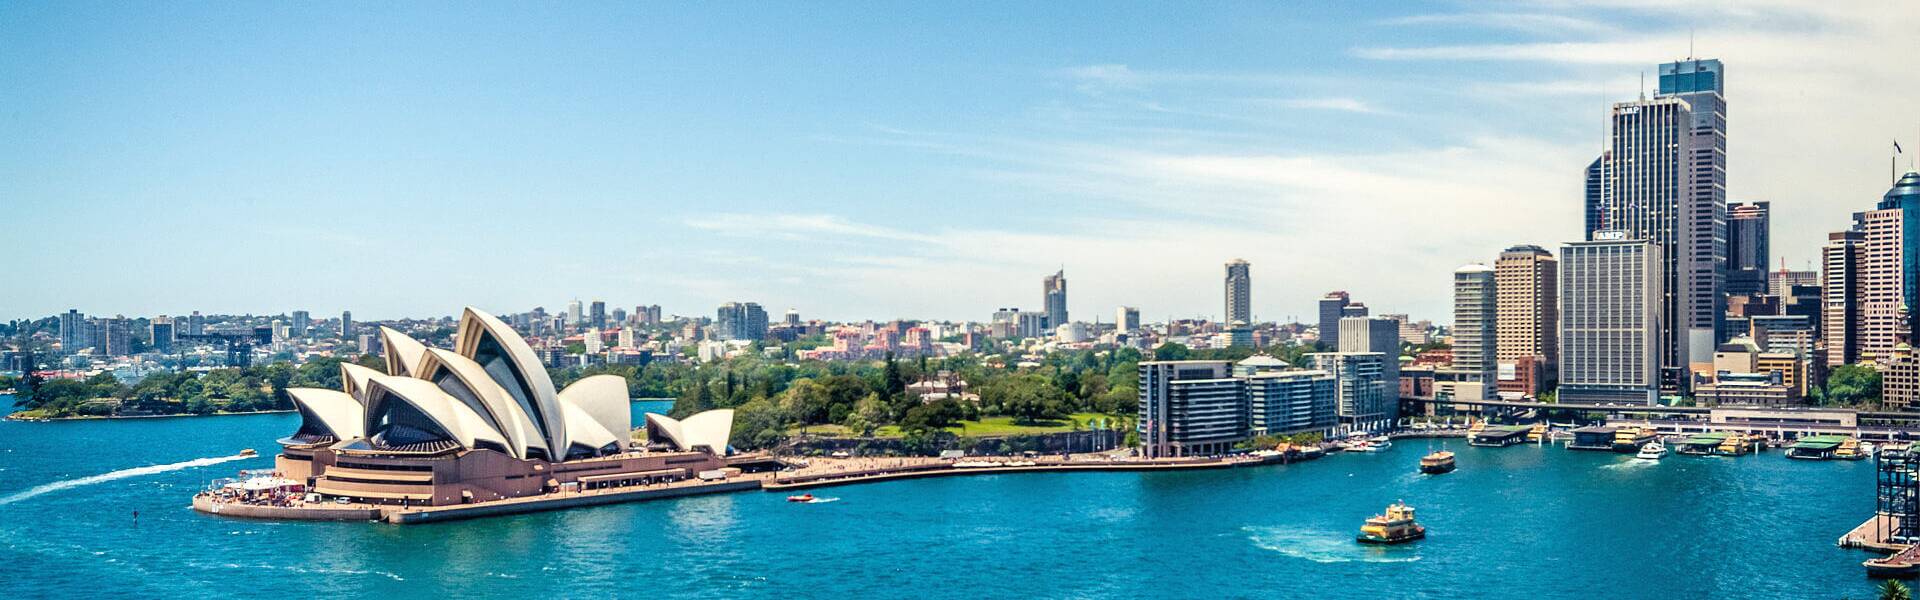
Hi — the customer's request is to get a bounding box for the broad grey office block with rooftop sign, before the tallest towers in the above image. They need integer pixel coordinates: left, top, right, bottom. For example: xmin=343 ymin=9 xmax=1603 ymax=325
xmin=1559 ymin=233 xmax=1665 ymax=404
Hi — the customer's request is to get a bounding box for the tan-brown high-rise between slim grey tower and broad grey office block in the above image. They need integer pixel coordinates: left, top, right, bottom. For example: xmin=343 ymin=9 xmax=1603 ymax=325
xmin=1497 ymin=246 xmax=1559 ymax=396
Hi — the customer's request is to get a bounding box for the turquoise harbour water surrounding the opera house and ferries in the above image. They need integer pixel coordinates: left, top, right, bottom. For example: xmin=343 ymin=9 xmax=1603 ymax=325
xmin=0 ymin=394 xmax=1872 ymax=598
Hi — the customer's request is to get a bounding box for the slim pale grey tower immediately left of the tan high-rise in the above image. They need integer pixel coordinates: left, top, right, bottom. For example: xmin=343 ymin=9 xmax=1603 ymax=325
xmin=1436 ymin=265 xmax=1500 ymax=400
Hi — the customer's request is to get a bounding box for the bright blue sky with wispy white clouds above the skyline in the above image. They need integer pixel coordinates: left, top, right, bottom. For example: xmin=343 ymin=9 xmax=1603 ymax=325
xmin=0 ymin=0 xmax=1920 ymax=323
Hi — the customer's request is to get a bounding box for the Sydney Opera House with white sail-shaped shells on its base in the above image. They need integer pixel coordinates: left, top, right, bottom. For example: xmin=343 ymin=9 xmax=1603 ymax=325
xmin=276 ymin=308 xmax=751 ymax=506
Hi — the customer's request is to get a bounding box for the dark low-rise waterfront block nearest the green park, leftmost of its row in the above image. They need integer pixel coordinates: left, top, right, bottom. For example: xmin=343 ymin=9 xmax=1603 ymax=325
xmin=1137 ymin=360 xmax=1252 ymax=458
